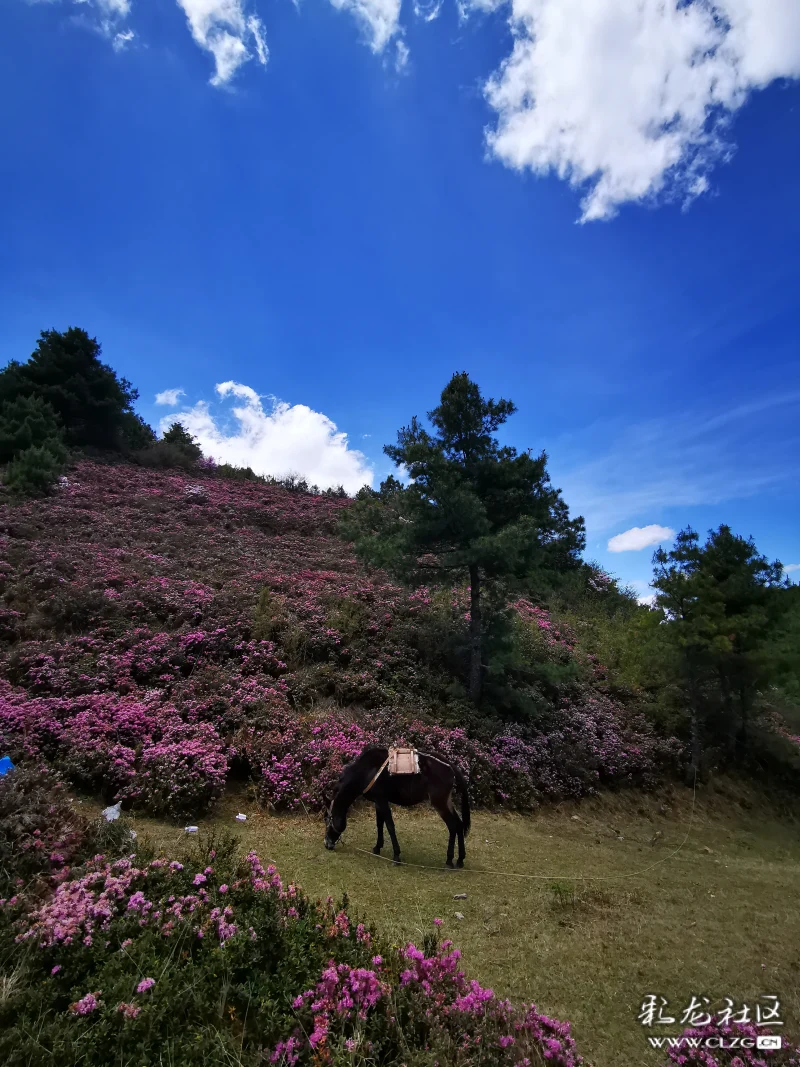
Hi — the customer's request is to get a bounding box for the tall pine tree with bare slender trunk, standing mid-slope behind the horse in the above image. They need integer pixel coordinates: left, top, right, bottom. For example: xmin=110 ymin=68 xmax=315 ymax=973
xmin=343 ymin=373 xmax=586 ymax=703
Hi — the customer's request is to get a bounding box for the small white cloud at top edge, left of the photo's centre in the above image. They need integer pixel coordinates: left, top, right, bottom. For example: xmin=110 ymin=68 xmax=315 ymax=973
xmin=178 ymin=0 xmax=269 ymax=85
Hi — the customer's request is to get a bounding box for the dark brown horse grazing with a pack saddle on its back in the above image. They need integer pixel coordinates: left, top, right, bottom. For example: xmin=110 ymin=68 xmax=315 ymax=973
xmin=325 ymin=748 xmax=469 ymax=867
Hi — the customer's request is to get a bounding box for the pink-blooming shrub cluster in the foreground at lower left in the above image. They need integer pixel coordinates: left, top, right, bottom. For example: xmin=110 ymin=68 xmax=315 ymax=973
xmin=0 ymin=773 xmax=597 ymax=1067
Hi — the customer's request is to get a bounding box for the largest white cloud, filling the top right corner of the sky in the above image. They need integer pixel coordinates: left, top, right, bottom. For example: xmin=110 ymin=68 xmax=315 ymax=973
xmin=480 ymin=0 xmax=800 ymax=221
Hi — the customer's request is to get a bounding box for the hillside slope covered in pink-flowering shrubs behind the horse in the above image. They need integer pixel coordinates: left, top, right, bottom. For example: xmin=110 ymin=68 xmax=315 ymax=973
xmin=0 ymin=461 xmax=677 ymax=816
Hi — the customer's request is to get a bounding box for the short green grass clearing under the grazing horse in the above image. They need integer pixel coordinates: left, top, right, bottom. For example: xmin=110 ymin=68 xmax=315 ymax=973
xmin=84 ymin=782 xmax=800 ymax=1067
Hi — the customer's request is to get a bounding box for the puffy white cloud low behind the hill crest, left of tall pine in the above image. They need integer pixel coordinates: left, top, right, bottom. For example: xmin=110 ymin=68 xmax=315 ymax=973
xmin=161 ymin=382 xmax=373 ymax=493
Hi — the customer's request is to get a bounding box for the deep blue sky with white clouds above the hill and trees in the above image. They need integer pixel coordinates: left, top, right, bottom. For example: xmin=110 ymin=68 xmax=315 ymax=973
xmin=0 ymin=0 xmax=800 ymax=593
